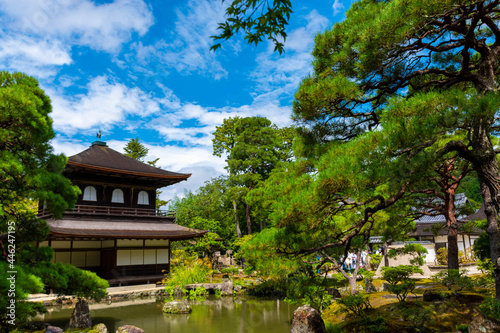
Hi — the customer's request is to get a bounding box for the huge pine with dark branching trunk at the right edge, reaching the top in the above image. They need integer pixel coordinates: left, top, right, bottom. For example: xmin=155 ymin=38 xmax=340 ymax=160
xmin=294 ymin=0 xmax=500 ymax=298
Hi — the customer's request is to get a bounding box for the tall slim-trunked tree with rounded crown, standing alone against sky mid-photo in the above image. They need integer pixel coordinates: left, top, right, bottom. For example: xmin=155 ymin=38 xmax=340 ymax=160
xmin=213 ymin=117 xmax=291 ymax=237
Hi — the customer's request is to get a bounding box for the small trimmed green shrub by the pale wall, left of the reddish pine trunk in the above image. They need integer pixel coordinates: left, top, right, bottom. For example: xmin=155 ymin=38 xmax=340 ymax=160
xmin=382 ymin=265 xmax=424 ymax=302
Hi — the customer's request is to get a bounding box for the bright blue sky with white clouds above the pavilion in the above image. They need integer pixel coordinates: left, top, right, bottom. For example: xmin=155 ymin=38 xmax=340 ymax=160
xmin=0 ymin=0 xmax=351 ymax=199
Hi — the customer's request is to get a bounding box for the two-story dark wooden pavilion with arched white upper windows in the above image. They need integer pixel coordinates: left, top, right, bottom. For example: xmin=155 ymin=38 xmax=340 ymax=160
xmin=38 ymin=141 xmax=206 ymax=285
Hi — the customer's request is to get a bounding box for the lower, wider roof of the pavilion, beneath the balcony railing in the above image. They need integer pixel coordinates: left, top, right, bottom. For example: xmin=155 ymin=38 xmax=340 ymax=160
xmin=47 ymin=218 xmax=207 ymax=240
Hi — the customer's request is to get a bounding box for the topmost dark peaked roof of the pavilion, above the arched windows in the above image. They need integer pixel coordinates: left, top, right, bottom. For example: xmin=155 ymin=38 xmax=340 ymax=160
xmin=67 ymin=142 xmax=191 ymax=183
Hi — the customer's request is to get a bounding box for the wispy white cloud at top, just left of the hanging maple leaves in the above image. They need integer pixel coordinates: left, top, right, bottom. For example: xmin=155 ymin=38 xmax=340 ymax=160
xmin=135 ymin=0 xmax=228 ymax=80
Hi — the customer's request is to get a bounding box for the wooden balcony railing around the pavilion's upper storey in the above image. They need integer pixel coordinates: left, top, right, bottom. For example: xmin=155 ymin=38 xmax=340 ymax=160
xmin=38 ymin=205 xmax=175 ymax=218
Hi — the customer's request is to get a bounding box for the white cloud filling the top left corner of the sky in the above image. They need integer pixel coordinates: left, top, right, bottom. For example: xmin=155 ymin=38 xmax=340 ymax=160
xmin=0 ymin=0 xmax=153 ymax=52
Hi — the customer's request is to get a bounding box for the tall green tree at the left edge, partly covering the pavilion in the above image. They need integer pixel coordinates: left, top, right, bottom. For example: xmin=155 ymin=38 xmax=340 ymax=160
xmin=0 ymin=72 xmax=96 ymax=331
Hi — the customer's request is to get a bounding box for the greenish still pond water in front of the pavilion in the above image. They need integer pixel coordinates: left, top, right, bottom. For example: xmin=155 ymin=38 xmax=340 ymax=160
xmin=39 ymin=296 xmax=296 ymax=333
